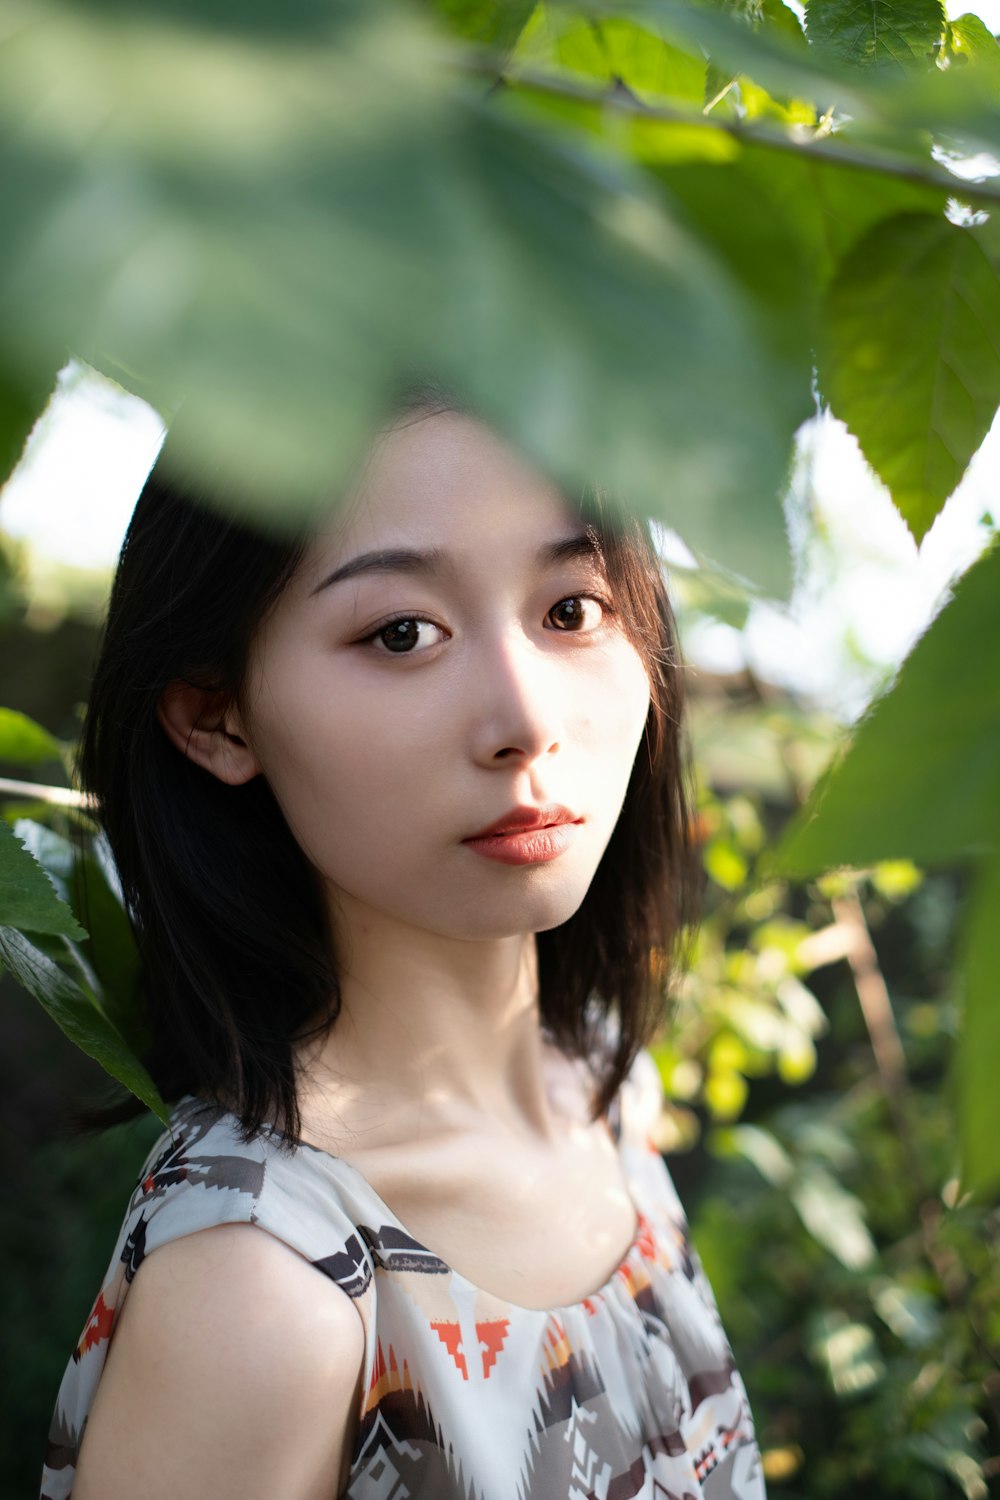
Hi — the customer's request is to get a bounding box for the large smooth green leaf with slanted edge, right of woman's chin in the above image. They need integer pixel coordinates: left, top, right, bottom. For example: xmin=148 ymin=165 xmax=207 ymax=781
xmin=762 ymin=543 xmax=1000 ymax=878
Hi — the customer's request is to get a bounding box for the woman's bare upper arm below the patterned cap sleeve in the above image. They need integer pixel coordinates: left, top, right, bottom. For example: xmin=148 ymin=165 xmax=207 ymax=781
xmin=73 ymin=1224 xmax=364 ymax=1500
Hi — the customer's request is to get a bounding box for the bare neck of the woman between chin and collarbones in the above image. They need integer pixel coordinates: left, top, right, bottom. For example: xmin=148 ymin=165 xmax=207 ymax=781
xmin=298 ymin=902 xmax=569 ymax=1149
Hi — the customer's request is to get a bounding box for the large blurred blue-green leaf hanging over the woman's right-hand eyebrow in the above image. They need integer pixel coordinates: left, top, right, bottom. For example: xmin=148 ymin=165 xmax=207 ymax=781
xmin=433 ymin=102 xmax=813 ymax=591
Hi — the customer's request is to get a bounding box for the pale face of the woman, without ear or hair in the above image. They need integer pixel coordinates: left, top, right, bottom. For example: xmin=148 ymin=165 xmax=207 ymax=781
xmin=240 ymin=413 xmax=649 ymax=939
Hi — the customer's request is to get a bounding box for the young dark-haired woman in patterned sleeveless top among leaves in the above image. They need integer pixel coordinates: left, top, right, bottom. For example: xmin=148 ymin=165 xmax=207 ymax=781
xmin=42 ymin=398 xmax=763 ymax=1500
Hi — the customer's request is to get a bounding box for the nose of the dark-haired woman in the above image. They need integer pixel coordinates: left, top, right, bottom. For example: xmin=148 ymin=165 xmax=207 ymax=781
xmin=468 ymin=630 xmax=565 ymax=765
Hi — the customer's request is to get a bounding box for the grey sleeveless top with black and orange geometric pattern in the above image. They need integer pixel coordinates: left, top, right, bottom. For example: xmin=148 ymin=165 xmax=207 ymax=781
xmin=42 ymin=1055 xmax=765 ymax=1500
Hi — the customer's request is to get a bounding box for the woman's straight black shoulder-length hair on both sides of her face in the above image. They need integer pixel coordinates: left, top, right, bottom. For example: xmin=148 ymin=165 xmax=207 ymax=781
xmin=79 ymin=396 xmax=700 ymax=1142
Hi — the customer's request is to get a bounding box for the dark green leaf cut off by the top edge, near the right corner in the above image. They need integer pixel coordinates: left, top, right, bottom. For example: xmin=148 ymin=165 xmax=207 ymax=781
xmin=805 ymin=0 xmax=946 ymax=72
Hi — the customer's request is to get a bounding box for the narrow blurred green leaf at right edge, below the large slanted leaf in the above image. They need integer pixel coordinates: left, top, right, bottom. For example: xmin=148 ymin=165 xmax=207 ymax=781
xmin=955 ymin=852 xmax=1000 ymax=1194
